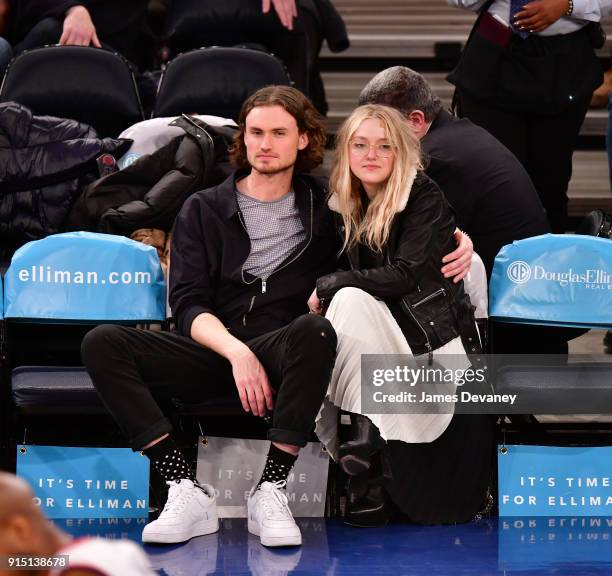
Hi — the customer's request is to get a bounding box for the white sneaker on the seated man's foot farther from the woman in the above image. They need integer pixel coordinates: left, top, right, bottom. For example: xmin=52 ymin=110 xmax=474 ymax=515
xmin=142 ymin=478 xmax=219 ymax=544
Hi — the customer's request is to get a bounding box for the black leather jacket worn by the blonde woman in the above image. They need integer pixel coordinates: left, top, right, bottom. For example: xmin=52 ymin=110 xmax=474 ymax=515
xmin=317 ymin=172 xmax=471 ymax=357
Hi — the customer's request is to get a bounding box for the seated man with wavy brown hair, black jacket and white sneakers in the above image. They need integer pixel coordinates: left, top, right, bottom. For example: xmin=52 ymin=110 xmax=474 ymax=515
xmin=82 ymin=86 xmax=336 ymax=546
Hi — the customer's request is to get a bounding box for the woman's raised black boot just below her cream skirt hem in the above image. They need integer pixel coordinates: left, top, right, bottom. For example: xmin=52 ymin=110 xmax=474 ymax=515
xmin=338 ymin=414 xmax=385 ymax=476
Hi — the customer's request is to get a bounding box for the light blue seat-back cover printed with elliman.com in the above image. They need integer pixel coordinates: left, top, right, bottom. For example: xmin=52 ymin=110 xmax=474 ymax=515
xmin=4 ymin=232 xmax=166 ymax=322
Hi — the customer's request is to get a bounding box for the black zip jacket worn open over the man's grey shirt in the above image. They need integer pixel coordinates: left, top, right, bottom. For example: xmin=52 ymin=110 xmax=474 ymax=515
xmin=170 ymin=172 xmax=338 ymax=341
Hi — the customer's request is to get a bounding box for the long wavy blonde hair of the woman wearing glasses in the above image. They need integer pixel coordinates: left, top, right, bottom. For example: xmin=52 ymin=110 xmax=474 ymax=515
xmin=330 ymin=104 xmax=423 ymax=253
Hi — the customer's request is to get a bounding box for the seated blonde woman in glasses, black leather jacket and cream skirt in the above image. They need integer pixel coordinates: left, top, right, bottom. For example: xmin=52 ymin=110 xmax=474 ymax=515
xmin=308 ymin=105 xmax=488 ymax=524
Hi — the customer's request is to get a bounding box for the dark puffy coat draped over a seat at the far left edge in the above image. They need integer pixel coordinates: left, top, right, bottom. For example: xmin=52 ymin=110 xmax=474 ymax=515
xmin=0 ymin=102 xmax=131 ymax=252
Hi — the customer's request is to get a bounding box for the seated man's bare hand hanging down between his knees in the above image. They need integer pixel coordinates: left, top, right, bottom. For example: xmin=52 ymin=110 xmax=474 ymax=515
xmin=230 ymin=345 xmax=274 ymax=417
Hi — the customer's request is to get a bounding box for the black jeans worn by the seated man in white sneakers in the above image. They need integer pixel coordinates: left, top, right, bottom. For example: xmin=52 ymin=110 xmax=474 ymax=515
xmin=81 ymin=314 xmax=336 ymax=450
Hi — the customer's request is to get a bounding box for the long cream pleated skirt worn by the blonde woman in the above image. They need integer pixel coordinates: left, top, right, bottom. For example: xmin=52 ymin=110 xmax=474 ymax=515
xmin=315 ymin=288 xmax=470 ymax=459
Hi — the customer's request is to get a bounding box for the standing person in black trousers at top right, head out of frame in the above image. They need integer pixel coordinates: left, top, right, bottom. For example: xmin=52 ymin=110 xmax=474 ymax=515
xmin=448 ymin=0 xmax=612 ymax=234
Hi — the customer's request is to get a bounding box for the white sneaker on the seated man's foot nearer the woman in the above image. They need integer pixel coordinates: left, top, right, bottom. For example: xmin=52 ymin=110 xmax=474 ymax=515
xmin=247 ymin=480 xmax=302 ymax=546
